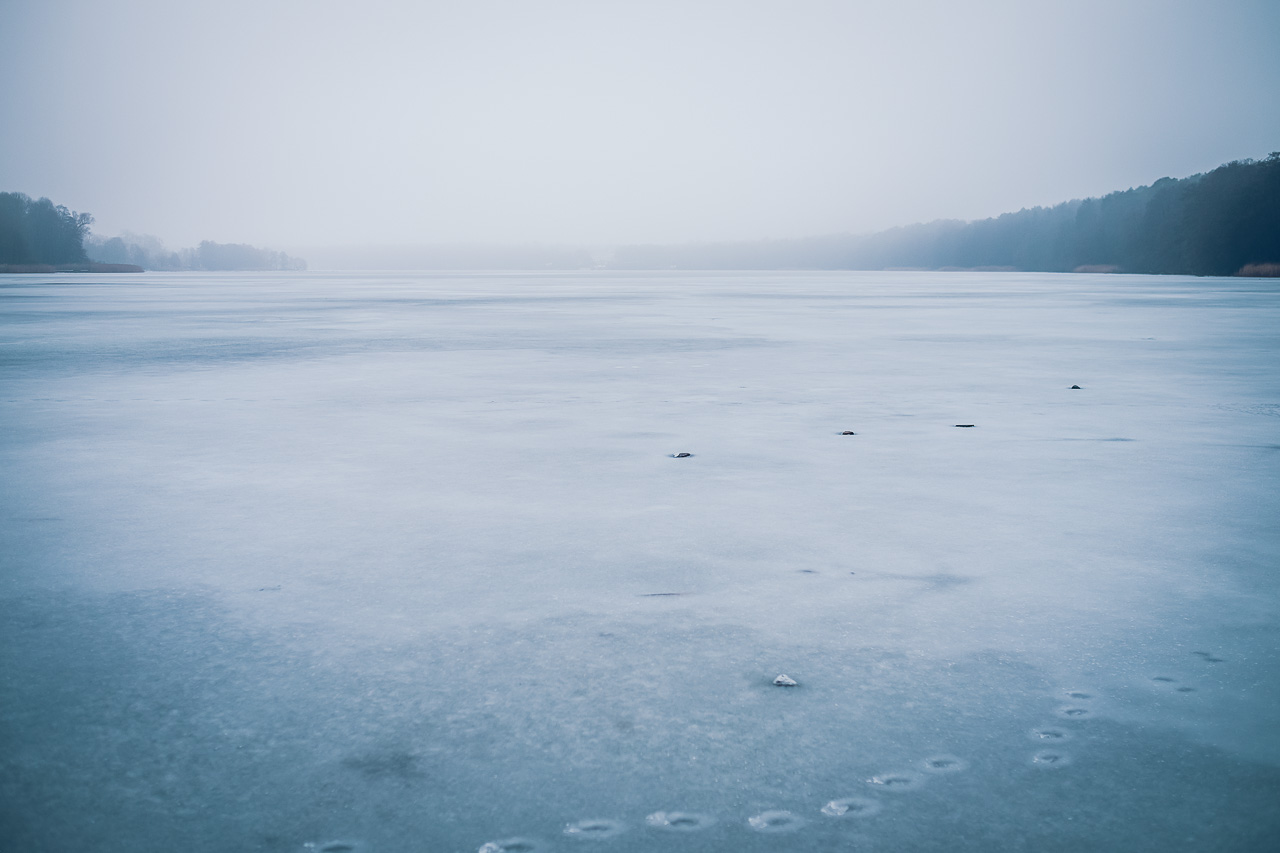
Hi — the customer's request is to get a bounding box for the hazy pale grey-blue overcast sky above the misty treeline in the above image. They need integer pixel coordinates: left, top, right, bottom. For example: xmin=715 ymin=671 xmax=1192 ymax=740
xmin=0 ymin=0 xmax=1280 ymax=250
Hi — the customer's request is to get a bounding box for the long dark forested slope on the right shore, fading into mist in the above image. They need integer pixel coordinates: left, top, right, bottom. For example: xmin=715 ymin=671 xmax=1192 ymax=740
xmin=609 ymin=151 xmax=1280 ymax=275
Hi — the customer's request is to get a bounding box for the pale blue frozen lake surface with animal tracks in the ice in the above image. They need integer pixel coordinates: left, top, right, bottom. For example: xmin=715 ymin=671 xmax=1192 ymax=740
xmin=0 ymin=273 xmax=1280 ymax=853
